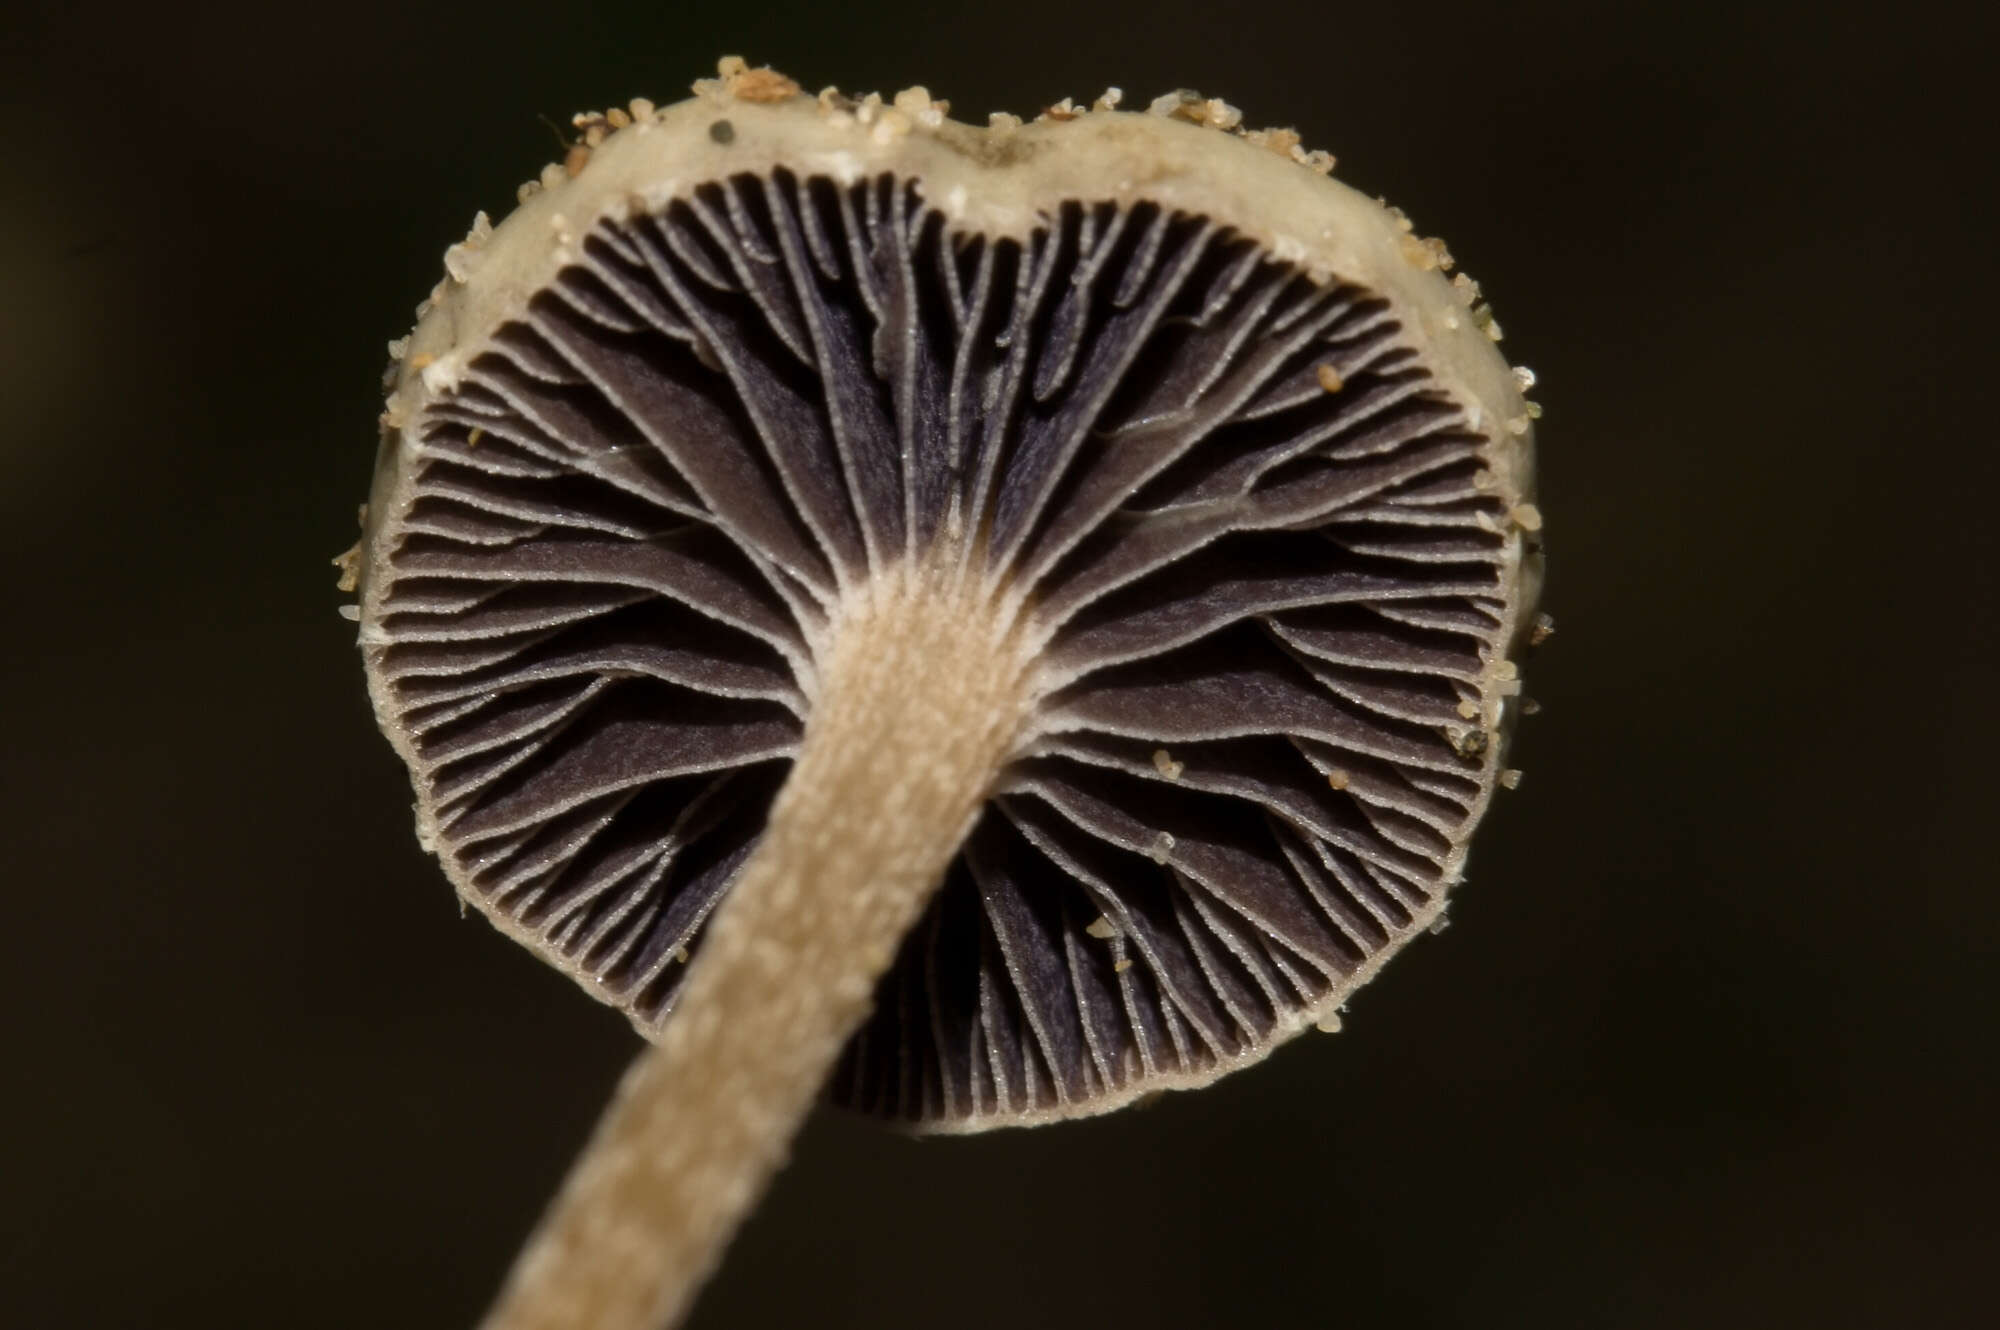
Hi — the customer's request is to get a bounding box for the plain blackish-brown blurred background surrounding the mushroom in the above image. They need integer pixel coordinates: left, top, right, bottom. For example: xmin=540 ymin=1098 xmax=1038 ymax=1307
xmin=0 ymin=2 xmax=2000 ymax=1330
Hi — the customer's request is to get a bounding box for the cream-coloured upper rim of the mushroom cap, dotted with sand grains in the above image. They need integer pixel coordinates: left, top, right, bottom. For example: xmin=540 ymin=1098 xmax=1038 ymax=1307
xmin=372 ymin=92 xmax=1532 ymax=504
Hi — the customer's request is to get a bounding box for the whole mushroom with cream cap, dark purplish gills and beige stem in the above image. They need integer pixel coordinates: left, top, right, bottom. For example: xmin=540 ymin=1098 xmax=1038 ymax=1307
xmin=348 ymin=62 xmax=1540 ymax=1330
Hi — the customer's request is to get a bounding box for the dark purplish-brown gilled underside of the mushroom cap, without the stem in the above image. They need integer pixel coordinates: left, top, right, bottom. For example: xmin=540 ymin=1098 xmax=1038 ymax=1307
xmin=364 ymin=96 xmax=1528 ymax=1130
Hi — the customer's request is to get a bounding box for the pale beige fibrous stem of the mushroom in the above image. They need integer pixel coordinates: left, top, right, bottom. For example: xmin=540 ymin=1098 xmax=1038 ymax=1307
xmin=484 ymin=570 xmax=1028 ymax=1330
